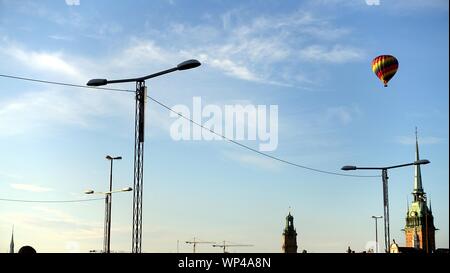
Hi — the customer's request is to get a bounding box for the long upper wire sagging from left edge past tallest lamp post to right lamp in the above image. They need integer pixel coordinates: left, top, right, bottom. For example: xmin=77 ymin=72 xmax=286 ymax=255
xmin=0 ymin=74 xmax=380 ymax=177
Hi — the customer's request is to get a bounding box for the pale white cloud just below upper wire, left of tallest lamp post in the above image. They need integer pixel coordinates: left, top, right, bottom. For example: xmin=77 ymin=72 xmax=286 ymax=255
xmin=0 ymin=89 xmax=133 ymax=137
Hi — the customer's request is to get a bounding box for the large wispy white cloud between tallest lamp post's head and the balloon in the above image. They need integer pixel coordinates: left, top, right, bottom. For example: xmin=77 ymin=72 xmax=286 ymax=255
xmin=169 ymin=9 xmax=364 ymax=86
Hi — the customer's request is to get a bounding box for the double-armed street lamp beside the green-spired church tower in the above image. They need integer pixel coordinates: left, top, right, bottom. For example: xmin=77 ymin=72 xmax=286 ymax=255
xmin=341 ymin=159 xmax=430 ymax=252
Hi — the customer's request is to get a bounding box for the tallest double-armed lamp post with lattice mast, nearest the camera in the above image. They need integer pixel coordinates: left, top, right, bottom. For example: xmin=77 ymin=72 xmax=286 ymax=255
xmin=87 ymin=60 xmax=201 ymax=253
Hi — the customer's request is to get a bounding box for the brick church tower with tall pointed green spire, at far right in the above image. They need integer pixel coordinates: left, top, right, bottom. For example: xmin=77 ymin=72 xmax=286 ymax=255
xmin=405 ymin=128 xmax=436 ymax=253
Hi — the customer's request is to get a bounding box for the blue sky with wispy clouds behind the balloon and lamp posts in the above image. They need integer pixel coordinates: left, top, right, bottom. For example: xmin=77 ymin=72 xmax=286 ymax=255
xmin=0 ymin=0 xmax=449 ymax=252
